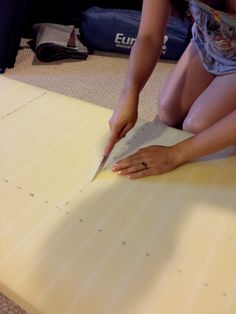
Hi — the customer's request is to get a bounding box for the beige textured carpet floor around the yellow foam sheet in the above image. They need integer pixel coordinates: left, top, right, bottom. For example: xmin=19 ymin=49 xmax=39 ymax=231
xmin=0 ymin=39 xmax=174 ymax=314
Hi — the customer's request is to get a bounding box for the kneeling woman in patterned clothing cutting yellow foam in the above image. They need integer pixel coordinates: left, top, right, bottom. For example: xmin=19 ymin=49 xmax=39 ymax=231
xmin=104 ymin=0 xmax=236 ymax=179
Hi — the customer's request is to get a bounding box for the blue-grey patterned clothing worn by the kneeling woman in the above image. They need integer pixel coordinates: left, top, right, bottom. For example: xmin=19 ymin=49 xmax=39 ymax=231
xmin=189 ymin=0 xmax=236 ymax=75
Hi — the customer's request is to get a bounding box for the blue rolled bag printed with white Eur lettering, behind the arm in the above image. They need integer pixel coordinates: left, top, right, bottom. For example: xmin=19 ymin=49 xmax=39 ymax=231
xmin=80 ymin=7 xmax=191 ymax=60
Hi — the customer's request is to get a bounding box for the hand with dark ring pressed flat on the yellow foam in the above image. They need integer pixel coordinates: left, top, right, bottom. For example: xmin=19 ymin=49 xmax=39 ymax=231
xmin=112 ymin=145 xmax=183 ymax=179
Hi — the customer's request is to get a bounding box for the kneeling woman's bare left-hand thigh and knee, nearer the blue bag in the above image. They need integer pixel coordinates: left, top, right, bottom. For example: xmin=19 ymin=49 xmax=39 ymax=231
xmin=157 ymin=42 xmax=215 ymax=126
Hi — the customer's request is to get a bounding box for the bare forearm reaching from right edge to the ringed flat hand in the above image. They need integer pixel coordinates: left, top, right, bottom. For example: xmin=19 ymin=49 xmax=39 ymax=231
xmin=174 ymin=110 xmax=236 ymax=164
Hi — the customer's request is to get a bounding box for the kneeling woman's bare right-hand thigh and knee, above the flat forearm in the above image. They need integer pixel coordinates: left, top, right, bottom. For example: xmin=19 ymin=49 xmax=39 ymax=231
xmin=183 ymin=73 xmax=236 ymax=133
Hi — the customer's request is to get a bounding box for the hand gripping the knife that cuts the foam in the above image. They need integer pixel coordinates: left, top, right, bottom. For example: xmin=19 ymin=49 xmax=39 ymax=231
xmin=103 ymin=95 xmax=139 ymax=156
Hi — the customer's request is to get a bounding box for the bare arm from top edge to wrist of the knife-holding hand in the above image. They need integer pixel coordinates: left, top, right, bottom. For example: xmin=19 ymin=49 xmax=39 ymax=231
xmin=122 ymin=0 xmax=170 ymax=96
